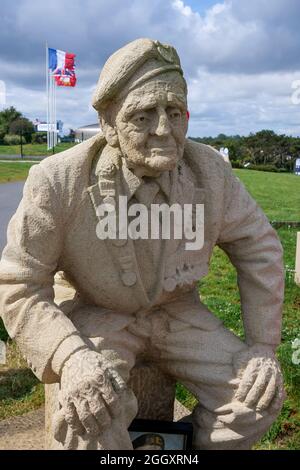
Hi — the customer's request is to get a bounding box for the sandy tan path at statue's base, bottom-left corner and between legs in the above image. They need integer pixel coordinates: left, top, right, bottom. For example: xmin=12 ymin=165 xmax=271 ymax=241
xmin=0 ymin=400 xmax=189 ymax=450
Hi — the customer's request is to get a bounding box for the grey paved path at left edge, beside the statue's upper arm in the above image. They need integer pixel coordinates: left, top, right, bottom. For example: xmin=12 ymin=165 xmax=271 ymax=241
xmin=0 ymin=181 xmax=24 ymax=254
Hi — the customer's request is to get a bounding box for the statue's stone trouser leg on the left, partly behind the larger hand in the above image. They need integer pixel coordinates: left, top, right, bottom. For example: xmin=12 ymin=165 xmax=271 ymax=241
xmin=49 ymin=307 xmax=143 ymax=450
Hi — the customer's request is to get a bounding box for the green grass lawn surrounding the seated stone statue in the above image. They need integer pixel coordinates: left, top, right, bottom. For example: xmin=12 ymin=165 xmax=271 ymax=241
xmin=0 ymin=164 xmax=300 ymax=450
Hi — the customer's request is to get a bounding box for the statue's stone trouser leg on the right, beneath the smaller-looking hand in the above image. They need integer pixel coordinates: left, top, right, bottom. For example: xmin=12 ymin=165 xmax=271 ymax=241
xmin=153 ymin=304 xmax=280 ymax=449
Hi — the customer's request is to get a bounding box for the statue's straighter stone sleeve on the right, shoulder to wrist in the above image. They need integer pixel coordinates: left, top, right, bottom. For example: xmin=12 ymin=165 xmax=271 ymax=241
xmin=217 ymin=165 xmax=284 ymax=347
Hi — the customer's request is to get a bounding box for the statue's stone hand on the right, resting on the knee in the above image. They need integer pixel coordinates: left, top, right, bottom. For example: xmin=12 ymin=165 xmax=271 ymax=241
xmin=234 ymin=344 xmax=284 ymax=412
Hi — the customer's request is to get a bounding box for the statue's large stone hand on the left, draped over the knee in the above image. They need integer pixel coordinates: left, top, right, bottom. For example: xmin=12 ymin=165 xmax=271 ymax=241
xmin=56 ymin=349 xmax=126 ymax=447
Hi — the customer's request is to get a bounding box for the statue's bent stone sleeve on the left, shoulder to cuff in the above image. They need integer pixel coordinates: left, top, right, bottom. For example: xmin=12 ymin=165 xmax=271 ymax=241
xmin=0 ymin=165 xmax=86 ymax=383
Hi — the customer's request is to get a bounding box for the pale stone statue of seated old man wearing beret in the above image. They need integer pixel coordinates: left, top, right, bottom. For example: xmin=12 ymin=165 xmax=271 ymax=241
xmin=0 ymin=39 xmax=284 ymax=450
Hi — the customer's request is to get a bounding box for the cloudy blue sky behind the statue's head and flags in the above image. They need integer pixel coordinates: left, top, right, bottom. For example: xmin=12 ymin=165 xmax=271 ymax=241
xmin=0 ymin=0 xmax=300 ymax=136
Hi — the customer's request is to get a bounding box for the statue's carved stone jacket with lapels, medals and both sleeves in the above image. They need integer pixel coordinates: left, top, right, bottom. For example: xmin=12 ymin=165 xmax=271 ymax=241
xmin=0 ymin=134 xmax=283 ymax=383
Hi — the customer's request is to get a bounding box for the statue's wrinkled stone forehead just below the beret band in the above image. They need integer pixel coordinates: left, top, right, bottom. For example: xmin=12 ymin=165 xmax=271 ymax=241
xmin=118 ymin=74 xmax=187 ymax=114
